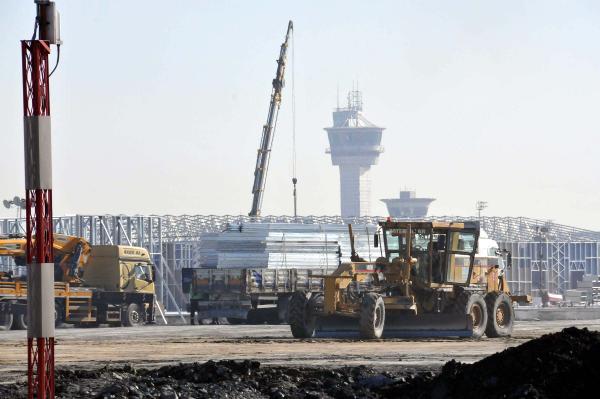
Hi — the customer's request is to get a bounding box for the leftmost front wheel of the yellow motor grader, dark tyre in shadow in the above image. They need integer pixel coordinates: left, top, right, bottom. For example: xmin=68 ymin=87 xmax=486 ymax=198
xmin=289 ymin=290 xmax=323 ymax=338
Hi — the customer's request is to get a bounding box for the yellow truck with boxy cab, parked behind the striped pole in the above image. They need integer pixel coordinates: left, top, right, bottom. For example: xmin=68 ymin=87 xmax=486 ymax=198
xmin=0 ymin=235 xmax=155 ymax=329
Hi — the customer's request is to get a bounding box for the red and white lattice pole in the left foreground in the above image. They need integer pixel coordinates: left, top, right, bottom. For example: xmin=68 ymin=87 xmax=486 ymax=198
xmin=21 ymin=0 xmax=60 ymax=399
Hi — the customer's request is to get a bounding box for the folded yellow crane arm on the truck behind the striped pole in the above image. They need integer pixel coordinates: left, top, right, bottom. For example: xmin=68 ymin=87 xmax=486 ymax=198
xmin=0 ymin=234 xmax=92 ymax=283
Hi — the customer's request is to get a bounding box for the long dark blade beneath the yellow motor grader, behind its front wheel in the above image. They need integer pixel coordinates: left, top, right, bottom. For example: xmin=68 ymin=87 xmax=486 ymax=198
xmin=315 ymin=313 xmax=473 ymax=338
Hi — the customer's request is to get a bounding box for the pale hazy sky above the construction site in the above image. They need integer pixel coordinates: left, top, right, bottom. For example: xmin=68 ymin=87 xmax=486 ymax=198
xmin=0 ymin=0 xmax=600 ymax=230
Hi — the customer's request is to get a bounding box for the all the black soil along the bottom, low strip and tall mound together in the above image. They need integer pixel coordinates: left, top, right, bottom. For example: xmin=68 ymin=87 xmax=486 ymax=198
xmin=0 ymin=328 xmax=600 ymax=399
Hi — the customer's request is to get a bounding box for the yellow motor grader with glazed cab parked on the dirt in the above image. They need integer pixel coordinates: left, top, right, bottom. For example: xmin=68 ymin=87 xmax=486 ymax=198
xmin=289 ymin=220 xmax=528 ymax=339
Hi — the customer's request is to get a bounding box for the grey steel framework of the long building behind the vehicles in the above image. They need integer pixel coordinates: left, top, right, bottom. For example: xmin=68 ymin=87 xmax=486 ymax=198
xmin=0 ymin=215 xmax=600 ymax=312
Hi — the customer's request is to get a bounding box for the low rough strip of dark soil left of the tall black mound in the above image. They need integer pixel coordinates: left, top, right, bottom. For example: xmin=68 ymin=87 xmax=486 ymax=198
xmin=0 ymin=360 xmax=422 ymax=399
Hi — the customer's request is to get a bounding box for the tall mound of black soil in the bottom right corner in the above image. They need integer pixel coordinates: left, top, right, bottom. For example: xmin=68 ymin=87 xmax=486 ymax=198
xmin=380 ymin=327 xmax=600 ymax=398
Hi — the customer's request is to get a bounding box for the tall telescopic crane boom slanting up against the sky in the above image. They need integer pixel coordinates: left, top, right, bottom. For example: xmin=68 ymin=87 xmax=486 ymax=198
xmin=248 ymin=21 xmax=294 ymax=217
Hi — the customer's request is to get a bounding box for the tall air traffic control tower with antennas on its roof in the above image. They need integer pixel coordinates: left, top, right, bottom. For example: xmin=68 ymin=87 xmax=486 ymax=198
xmin=325 ymin=90 xmax=384 ymax=218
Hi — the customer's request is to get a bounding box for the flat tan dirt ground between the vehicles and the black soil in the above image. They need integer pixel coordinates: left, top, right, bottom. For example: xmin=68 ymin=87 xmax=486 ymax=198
xmin=0 ymin=320 xmax=600 ymax=383
